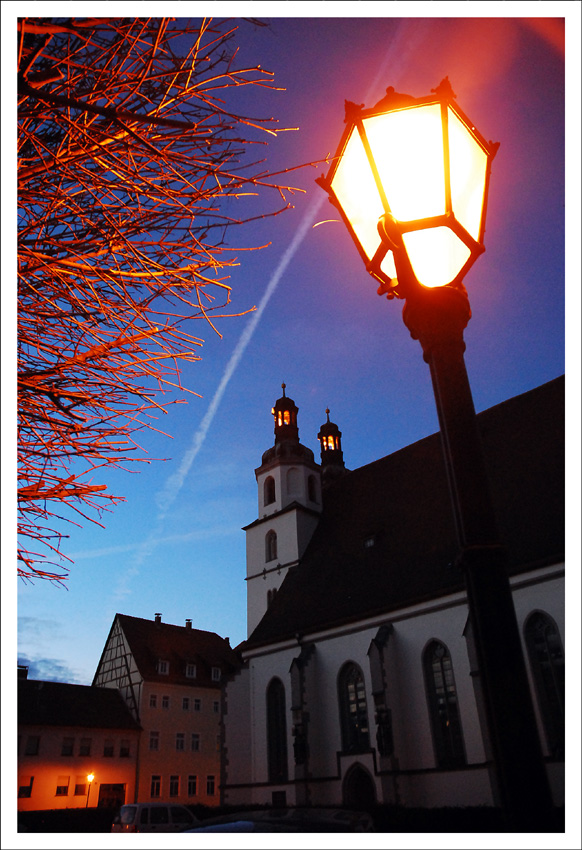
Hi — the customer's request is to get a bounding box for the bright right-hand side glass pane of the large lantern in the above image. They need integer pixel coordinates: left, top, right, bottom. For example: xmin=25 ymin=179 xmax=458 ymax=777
xmin=449 ymin=108 xmax=487 ymax=241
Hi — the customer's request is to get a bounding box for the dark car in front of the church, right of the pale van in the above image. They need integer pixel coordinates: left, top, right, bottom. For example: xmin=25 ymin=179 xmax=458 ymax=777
xmin=185 ymin=807 xmax=375 ymax=832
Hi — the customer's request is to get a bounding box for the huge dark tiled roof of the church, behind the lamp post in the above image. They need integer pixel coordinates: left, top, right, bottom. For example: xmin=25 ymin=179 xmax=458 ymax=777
xmin=245 ymin=376 xmax=565 ymax=649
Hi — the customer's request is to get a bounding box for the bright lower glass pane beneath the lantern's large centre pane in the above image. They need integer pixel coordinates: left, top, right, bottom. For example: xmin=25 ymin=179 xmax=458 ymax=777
xmin=402 ymin=227 xmax=471 ymax=289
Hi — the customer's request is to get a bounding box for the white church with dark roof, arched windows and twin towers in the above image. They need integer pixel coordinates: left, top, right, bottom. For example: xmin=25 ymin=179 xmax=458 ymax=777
xmin=221 ymin=376 xmax=565 ymax=808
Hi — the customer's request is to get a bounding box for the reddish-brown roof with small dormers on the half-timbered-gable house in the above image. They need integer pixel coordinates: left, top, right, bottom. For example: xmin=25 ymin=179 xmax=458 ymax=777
xmin=116 ymin=614 xmax=237 ymax=688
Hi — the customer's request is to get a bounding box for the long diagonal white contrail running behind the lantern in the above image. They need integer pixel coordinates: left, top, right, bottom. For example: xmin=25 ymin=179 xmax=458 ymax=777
xmin=115 ymin=19 xmax=430 ymax=598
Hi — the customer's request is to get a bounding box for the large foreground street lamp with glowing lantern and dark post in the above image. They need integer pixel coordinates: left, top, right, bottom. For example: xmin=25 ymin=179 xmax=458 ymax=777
xmin=317 ymin=78 xmax=552 ymax=827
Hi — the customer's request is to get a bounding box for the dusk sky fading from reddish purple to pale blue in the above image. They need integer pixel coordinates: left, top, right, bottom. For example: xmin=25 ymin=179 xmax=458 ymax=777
xmin=3 ymin=8 xmax=580 ymax=696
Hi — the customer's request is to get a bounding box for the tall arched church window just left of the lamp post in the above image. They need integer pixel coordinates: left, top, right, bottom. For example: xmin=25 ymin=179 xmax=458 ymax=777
xmin=423 ymin=640 xmax=466 ymax=768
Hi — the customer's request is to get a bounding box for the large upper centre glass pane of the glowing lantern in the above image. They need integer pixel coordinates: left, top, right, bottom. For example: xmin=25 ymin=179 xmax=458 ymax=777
xmin=364 ymin=104 xmax=445 ymax=222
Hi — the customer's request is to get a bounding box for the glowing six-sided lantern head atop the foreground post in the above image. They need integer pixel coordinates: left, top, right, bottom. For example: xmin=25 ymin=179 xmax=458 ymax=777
xmin=317 ymin=78 xmax=499 ymax=297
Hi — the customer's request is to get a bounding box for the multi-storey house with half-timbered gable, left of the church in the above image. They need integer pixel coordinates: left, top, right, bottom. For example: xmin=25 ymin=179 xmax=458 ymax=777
xmin=93 ymin=614 xmax=237 ymax=806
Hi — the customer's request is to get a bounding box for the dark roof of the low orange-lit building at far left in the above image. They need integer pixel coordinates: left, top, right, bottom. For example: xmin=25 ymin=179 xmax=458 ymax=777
xmin=18 ymin=679 xmax=141 ymax=729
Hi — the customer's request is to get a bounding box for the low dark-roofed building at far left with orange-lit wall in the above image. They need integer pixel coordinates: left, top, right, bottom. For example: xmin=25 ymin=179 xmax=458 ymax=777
xmin=18 ymin=668 xmax=140 ymax=811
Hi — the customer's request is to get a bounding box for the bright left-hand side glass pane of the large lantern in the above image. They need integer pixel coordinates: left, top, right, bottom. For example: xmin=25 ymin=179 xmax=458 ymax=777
xmin=331 ymin=127 xmax=384 ymax=259
